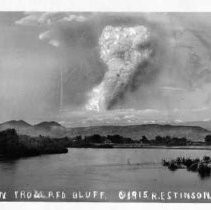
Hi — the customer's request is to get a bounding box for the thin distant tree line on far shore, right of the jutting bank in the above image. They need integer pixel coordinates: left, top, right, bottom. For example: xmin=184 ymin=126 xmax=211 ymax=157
xmin=70 ymin=134 xmax=211 ymax=150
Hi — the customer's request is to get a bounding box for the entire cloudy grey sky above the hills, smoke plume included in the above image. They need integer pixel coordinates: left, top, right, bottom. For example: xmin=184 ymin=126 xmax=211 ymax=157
xmin=0 ymin=12 xmax=211 ymax=126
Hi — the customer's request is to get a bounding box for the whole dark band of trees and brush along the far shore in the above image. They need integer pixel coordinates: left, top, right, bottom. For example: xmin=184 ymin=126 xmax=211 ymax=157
xmin=0 ymin=129 xmax=211 ymax=158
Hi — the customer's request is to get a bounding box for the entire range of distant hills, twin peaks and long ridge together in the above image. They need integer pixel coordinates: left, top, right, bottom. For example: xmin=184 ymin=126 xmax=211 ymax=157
xmin=0 ymin=120 xmax=211 ymax=141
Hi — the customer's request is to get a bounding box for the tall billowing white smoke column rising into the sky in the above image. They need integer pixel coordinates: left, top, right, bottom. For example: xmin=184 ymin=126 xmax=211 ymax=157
xmin=86 ymin=25 xmax=152 ymax=111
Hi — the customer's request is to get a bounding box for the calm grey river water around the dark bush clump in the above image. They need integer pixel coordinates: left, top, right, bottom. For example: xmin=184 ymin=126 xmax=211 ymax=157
xmin=0 ymin=149 xmax=211 ymax=202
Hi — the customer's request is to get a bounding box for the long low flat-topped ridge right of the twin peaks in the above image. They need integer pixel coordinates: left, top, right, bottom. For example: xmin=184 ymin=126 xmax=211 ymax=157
xmin=67 ymin=124 xmax=211 ymax=141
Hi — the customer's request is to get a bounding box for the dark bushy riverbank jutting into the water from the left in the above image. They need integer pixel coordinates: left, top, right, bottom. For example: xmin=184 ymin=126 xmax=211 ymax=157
xmin=0 ymin=129 xmax=68 ymax=158
